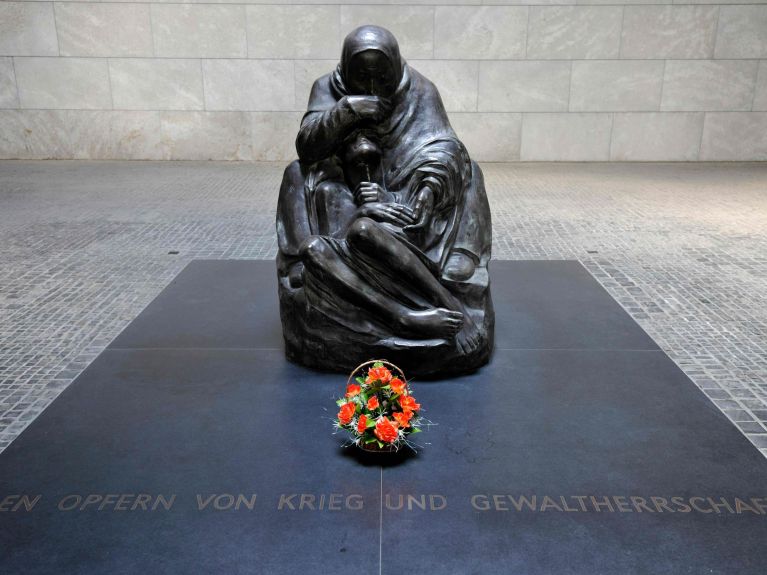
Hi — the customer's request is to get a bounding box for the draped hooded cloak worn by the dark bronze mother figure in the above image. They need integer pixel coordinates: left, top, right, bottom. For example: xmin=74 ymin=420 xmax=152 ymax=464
xmin=277 ymin=29 xmax=484 ymax=339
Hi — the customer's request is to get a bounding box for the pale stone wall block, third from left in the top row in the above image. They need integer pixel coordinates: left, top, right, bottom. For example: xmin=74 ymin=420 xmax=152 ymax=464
xmin=151 ymin=4 xmax=248 ymax=58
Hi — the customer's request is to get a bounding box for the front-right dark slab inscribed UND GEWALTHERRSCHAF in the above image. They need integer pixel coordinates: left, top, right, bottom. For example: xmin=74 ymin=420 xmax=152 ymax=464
xmin=382 ymin=348 xmax=767 ymax=575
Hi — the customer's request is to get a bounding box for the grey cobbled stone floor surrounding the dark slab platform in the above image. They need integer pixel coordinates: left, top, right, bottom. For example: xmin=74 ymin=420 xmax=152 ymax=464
xmin=0 ymin=161 xmax=767 ymax=456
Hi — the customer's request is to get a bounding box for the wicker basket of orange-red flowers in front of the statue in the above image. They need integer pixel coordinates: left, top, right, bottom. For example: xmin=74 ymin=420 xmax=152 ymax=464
xmin=335 ymin=359 xmax=421 ymax=453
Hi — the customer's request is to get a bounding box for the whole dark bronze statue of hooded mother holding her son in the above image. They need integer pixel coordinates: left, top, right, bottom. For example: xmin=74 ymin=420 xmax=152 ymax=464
xmin=277 ymin=26 xmax=493 ymax=373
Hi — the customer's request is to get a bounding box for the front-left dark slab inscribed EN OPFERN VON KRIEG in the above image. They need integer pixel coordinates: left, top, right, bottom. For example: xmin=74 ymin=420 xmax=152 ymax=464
xmin=0 ymin=349 xmax=380 ymax=575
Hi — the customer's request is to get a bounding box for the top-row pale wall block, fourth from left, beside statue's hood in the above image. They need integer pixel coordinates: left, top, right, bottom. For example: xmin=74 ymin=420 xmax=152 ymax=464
xmin=246 ymin=6 xmax=341 ymax=58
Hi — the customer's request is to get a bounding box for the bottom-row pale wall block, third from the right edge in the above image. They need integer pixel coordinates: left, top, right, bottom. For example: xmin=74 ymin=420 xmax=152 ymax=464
xmin=520 ymin=113 xmax=612 ymax=162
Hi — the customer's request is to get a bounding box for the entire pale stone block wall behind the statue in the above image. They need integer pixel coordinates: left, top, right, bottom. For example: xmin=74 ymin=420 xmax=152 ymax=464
xmin=0 ymin=0 xmax=767 ymax=161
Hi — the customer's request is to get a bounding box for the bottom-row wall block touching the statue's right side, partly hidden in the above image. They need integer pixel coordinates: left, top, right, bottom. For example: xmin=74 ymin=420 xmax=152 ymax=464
xmin=450 ymin=112 xmax=522 ymax=162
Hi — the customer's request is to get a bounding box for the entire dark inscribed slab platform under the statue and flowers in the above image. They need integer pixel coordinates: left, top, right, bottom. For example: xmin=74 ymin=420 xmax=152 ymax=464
xmin=0 ymin=260 xmax=767 ymax=575
